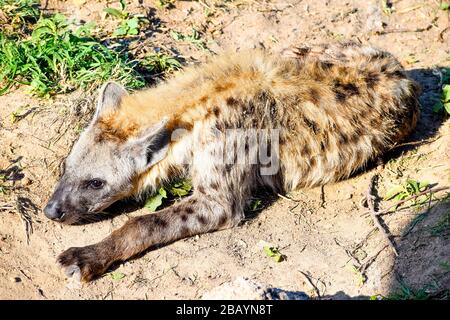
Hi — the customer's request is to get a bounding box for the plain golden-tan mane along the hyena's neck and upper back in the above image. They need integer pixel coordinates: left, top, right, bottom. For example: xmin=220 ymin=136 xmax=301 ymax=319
xmin=98 ymin=51 xmax=273 ymax=141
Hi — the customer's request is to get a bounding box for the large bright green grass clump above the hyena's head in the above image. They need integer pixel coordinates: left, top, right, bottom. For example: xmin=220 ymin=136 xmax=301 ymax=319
xmin=0 ymin=14 xmax=145 ymax=97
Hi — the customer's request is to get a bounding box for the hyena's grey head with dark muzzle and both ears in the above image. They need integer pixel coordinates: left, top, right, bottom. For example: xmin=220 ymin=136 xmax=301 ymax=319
xmin=44 ymin=83 xmax=169 ymax=223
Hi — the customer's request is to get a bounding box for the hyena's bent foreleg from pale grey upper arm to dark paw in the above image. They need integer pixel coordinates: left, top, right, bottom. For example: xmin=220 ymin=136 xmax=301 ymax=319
xmin=58 ymin=134 xmax=257 ymax=281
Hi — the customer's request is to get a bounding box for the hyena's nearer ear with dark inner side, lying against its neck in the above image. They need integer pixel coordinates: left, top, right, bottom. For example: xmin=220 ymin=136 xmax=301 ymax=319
xmin=126 ymin=119 xmax=170 ymax=171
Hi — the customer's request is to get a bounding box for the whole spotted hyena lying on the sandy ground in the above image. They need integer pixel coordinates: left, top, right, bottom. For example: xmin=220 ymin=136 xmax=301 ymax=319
xmin=44 ymin=43 xmax=419 ymax=281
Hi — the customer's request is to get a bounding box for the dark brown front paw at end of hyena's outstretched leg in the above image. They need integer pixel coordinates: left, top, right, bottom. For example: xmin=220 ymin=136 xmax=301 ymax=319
xmin=57 ymin=246 xmax=108 ymax=282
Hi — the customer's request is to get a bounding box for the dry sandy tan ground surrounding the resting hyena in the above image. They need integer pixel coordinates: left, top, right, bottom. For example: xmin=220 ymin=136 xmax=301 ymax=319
xmin=0 ymin=0 xmax=450 ymax=299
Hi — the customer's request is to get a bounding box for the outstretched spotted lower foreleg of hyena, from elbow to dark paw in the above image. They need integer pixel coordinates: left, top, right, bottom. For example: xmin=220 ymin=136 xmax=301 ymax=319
xmin=58 ymin=188 xmax=244 ymax=281
